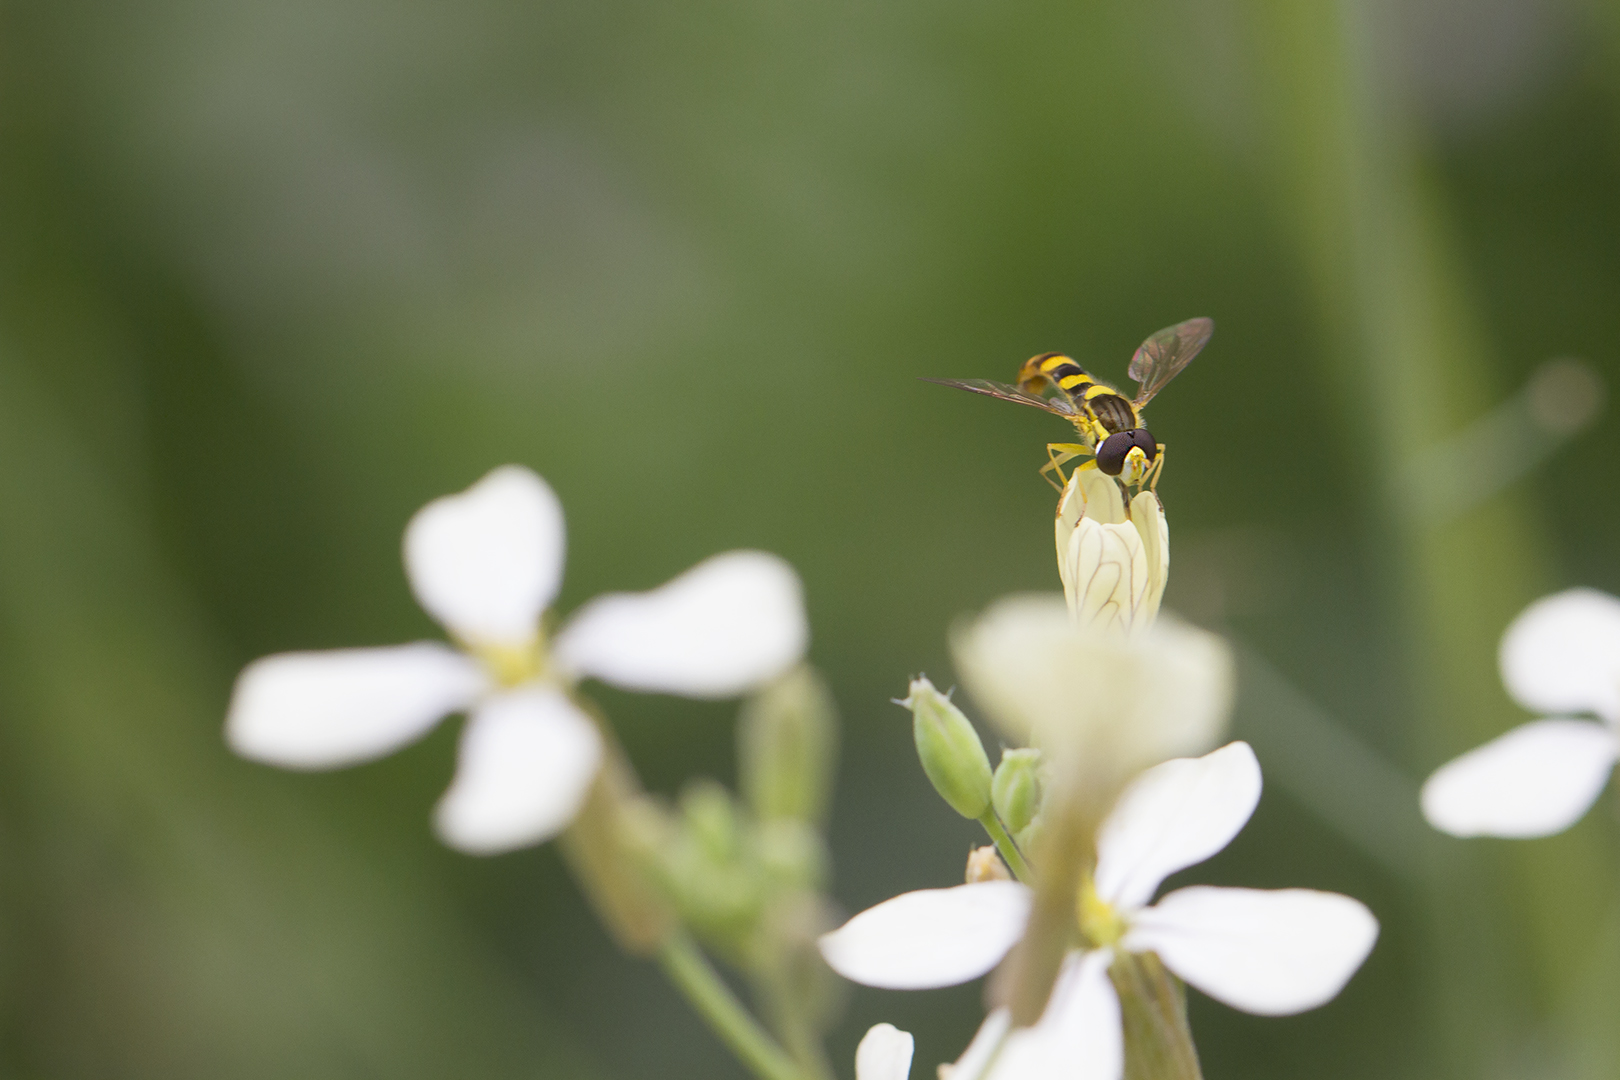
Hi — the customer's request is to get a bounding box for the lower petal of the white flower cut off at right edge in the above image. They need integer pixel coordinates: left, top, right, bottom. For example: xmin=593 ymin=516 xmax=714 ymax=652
xmin=1422 ymin=719 xmax=1620 ymax=837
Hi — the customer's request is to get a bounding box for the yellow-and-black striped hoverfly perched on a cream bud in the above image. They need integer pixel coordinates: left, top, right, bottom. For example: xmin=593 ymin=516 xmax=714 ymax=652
xmin=927 ymin=319 xmax=1215 ymax=491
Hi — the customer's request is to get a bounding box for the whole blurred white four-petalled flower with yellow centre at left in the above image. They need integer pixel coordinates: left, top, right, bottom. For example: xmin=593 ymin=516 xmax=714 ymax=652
xmin=225 ymin=465 xmax=808 ymax=853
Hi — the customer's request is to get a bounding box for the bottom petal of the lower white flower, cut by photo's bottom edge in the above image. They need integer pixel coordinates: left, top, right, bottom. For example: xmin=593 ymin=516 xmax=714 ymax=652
xmin=990 ymin=949 xmax=1124 ymax=1080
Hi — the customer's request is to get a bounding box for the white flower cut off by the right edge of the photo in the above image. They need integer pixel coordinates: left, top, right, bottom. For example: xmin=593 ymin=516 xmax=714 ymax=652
xmin=1422 ymin=589 xmax=1620 ymax=837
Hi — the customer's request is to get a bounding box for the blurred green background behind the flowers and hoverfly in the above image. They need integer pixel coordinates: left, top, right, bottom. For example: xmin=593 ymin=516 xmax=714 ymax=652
xmin=0 ymin=0 xmax=1620 ymax=1080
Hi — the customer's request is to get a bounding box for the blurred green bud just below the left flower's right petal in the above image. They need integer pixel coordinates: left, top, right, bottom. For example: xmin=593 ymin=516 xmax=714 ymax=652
xmin=737 ymin=664 xmax=838 ymax=821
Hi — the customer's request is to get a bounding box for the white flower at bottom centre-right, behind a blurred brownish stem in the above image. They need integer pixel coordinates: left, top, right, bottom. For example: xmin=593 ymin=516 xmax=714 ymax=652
xmin=821 ymin=743 xmax=1379 ymax=1080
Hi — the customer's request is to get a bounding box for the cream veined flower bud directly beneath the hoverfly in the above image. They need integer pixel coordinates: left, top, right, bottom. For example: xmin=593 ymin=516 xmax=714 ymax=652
xmin=1055 ymin=468 xmax=1170 ymax=633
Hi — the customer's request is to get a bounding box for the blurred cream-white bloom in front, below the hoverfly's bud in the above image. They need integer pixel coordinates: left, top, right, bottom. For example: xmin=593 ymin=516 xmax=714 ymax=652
xmin=951 ymin=595 xmax=1233 ymax=782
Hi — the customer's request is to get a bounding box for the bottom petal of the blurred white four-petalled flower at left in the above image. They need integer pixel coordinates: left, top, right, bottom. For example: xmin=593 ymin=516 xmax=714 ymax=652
xmin=434 ymin=687 xmax=601 ymax=855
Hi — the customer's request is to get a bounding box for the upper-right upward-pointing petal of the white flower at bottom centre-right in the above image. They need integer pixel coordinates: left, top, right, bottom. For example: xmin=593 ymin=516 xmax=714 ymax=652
xmin=1097 ymin=742 xmax=1260 ymax=912
